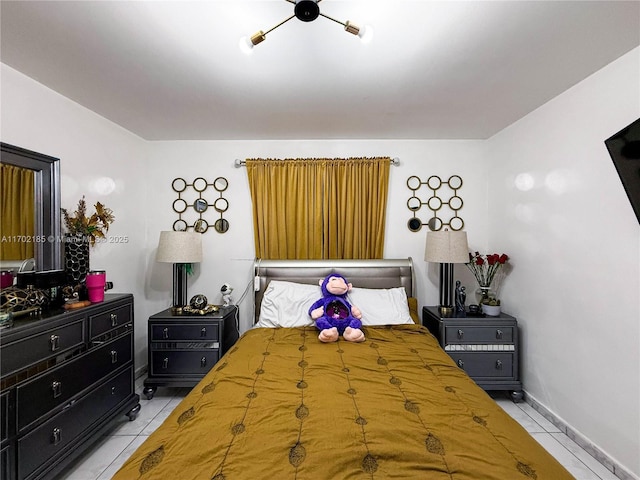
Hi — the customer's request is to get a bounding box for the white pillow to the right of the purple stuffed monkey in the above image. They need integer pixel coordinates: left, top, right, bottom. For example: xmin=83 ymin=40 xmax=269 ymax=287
xmin=347 ymin=287 xmax=415 ymax=325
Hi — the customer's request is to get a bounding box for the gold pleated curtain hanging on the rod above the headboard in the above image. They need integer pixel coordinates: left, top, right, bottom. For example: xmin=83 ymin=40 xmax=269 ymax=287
xmin=246 ymin=157 xmax=391 ymax=259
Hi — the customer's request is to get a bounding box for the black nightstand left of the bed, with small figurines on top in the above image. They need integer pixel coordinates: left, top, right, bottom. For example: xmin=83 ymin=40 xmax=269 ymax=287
xmin=143 ymin=305 xmax=238 ymax=400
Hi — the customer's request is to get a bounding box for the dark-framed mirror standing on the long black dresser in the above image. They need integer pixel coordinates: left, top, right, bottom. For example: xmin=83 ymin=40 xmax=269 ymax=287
xmin=0 ymin=142 xmax=62 ymax=271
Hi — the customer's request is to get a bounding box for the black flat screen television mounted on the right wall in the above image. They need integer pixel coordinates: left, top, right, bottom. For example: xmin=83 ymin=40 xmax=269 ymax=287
xmin=604 ymin=118 xmax=640 ymax=223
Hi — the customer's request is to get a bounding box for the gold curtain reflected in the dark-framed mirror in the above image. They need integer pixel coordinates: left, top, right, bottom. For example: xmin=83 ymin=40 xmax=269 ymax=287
xmin=0 ymin=164 xmax=35 ymax=260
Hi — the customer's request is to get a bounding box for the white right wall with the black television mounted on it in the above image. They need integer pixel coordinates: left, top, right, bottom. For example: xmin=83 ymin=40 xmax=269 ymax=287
xmin=487 ymin=49 xmax=640 ymax=476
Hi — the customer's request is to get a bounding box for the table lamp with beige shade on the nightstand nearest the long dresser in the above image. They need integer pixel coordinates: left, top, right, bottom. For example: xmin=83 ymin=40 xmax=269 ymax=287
xmin=156 ymin=231 xmax=202 ymax=315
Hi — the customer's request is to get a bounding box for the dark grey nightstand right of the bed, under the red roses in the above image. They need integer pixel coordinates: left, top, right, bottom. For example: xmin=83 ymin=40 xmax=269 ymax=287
xmin=422 ymin=307 xmax=523 ymax=402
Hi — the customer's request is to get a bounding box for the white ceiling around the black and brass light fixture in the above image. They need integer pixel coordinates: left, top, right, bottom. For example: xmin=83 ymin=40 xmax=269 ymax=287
xmin=0 ymin=0 xmax=640 ymax=140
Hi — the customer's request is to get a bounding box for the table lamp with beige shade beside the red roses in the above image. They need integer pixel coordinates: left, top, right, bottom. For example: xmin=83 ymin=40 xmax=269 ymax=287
xmin=424 ymin=229 xmax=469 ymax=316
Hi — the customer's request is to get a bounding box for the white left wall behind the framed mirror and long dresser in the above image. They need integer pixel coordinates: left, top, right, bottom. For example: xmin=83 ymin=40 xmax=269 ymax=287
xmin=0 ymin=65 xmax=148 ymax=366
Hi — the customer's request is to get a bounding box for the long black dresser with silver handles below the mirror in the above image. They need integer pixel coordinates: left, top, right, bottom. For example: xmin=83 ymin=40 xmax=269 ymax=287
xmin=0 ymin=294 xmax=140 ymax=480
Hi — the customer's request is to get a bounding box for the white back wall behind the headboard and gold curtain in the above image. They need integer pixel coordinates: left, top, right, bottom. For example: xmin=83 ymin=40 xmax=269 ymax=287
xmin=145 ymin=140 xmax=487 ymax=331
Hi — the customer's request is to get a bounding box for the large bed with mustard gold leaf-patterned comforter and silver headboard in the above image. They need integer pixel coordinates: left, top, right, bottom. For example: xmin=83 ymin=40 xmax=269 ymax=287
xmin=114 ymin=259 xmax=573 ymax=480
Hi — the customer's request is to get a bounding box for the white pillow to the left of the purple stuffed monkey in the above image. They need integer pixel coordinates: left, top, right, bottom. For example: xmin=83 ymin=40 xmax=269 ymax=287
xmin=255 ymin=280 xmax=322 ymax=328
